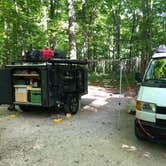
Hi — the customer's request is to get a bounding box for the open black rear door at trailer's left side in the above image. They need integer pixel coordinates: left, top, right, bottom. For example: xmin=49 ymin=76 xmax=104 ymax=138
xmin=0 ymin=69 xmax=12 ymax=104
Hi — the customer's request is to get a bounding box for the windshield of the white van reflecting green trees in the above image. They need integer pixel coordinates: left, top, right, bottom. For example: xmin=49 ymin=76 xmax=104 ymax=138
xmin=144 ymin=58 xmax=166 ymax=85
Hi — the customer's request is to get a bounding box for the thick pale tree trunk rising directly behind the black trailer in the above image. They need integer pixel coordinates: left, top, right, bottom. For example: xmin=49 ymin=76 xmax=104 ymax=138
xmin=68 ymin=0 xmax=77 ymax=59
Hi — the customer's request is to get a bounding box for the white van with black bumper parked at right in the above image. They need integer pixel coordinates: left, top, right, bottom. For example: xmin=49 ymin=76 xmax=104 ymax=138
xmin=135 ymin=52 xmax=166 ymax=142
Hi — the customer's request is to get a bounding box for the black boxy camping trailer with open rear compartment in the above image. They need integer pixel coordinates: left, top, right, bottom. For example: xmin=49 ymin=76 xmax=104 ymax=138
xmin=0 ymin=59 xmax=87 ymax=114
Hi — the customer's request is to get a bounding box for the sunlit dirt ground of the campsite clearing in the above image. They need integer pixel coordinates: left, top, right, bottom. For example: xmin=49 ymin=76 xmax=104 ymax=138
xmin=0 ymin=86 xmax=166 ymax=166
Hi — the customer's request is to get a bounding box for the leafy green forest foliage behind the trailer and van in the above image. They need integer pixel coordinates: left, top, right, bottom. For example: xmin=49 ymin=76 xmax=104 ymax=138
xmin=0 ymin=0 xmax=166 ymax=70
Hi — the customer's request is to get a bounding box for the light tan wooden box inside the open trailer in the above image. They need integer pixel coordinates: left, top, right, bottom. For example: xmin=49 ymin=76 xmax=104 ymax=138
xmin=14 ymin=85 xmax=28 ymax=102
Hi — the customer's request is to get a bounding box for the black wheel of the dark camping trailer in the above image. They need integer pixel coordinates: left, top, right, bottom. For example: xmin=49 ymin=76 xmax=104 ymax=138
xmin=64 ymin=95 xmax=80 ymax=115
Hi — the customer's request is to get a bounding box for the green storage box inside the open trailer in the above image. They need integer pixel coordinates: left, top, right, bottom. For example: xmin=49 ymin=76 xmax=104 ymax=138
xmin=29 ymin=88 xmax=41 ymax=104
